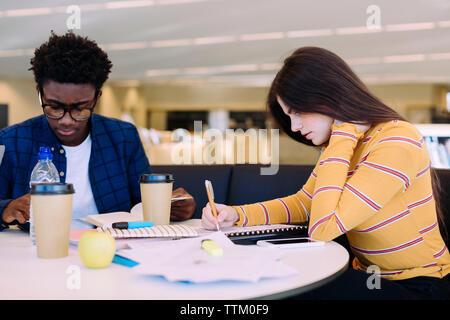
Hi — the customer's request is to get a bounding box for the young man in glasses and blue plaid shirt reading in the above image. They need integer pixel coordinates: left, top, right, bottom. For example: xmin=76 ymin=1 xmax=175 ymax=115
xmin=0 ymin=32 xmax=195 ymax=230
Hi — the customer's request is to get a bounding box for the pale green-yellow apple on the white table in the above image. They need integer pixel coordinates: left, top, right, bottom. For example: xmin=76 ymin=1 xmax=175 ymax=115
xmin=78 ymin=231 xmax=116 ymax=268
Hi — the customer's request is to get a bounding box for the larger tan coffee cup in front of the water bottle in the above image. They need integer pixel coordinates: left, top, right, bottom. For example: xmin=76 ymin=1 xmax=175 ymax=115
xmin=30 ymin=183 xmax=75 ymax=258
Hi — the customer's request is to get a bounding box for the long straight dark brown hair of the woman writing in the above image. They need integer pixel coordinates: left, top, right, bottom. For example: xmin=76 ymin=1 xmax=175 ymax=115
xmin=267 ymin=47 xmax=446 ymax=236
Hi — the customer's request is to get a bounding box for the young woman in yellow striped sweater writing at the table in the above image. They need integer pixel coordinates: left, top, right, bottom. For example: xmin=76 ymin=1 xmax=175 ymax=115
xmin=202 ymin=47 xmax=450 ymax=299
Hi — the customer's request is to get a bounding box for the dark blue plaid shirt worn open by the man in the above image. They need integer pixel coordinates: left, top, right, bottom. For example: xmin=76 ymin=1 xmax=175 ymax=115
xmin=0 ymin=114 xmax=151 ymax=231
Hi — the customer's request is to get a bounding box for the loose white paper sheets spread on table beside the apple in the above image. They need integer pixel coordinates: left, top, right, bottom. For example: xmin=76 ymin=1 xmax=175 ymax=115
xmin=118 ymin=232 xmax=298 ymax=282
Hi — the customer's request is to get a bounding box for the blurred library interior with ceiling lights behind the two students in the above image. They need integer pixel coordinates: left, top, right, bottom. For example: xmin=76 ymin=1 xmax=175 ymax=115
xmin=0 ymin=0 xmax=450 ymax=168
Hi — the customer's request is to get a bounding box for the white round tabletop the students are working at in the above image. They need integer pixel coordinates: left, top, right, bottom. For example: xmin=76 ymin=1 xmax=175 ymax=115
xmin=0 ymin=220 xmax=349 ymax=300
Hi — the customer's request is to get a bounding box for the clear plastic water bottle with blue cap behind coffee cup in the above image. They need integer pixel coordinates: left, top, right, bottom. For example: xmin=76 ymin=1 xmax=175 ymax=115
xmin=30 ymin=147 xmax=59 ymax=245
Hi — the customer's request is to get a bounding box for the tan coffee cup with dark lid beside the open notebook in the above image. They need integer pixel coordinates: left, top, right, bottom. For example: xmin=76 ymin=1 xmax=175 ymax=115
xmin=139 ymin=173 xmax=174 ymax=225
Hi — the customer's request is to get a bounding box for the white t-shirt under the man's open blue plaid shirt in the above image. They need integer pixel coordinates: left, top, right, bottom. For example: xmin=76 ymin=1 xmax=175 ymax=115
xmin=62 ymin=135 xmax=98 ymax=230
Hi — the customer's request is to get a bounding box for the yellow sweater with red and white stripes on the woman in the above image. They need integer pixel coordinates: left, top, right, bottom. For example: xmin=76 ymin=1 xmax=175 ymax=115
xmin=233 ymin=121 xmax=450 ymax=280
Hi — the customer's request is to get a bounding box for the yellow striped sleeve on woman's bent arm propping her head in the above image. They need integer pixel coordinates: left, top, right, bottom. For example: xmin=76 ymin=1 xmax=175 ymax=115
xmin=309 ymin=123 xmax=423 ymax=241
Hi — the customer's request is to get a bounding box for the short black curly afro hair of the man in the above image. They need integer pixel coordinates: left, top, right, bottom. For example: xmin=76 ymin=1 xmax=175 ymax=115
xmin=29 ymin=31 xmax=112 ymax=90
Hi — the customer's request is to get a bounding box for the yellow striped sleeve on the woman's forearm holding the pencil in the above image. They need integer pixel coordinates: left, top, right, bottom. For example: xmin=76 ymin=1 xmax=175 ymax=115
xmin=233 ymin=166 xmax=316 ymax=227
